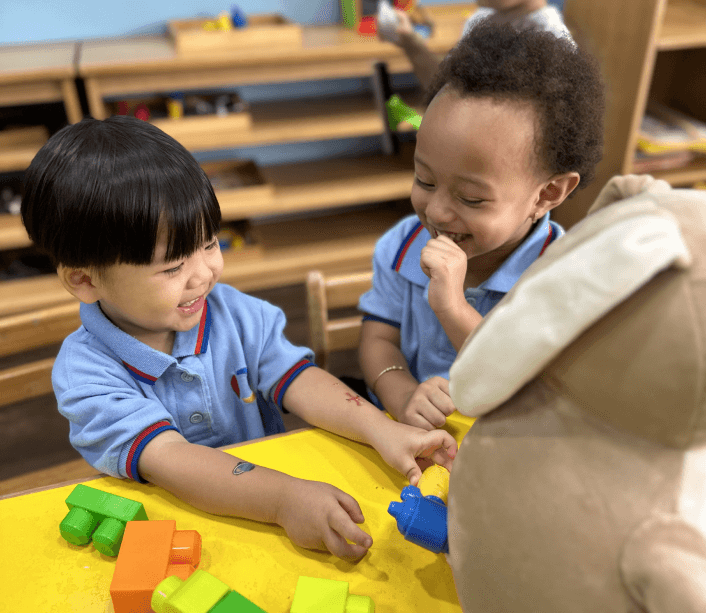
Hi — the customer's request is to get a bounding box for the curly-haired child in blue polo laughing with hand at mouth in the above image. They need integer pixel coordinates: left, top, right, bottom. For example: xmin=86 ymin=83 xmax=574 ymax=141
xmin=359 ymin=21 xmax=604 ymax=429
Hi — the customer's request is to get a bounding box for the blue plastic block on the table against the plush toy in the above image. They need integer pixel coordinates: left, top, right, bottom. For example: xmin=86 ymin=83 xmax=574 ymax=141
xmin=387 ymin=485 xmax=449 ymax=553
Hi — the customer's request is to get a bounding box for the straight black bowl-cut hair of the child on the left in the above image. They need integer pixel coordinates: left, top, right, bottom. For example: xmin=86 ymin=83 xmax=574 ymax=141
xmin=21 ymin=116 xmax=221 ymax=270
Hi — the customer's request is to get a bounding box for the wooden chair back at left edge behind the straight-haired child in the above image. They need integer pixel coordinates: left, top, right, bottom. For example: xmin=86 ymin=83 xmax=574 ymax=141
xmin=0 ymin=301 xmax=81 ymax=406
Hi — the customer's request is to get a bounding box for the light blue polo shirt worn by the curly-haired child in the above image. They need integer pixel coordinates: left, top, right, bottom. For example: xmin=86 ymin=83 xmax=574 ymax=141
xmin=358 ymin=213 xmax=564 ymax=382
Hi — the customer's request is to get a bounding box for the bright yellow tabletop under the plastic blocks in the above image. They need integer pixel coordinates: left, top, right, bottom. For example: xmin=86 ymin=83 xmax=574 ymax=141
xmin=0 ymin=413 xmax=473 ymax=613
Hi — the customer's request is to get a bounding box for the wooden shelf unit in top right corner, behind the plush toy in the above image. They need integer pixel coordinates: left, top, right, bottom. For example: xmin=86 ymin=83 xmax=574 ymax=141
xmin=553 ymin=0 xmax=706 ymax=228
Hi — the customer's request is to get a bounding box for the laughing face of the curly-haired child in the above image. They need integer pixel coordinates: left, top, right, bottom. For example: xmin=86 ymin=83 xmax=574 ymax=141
xmin=412 ymin=86 xmax=550 ymax=270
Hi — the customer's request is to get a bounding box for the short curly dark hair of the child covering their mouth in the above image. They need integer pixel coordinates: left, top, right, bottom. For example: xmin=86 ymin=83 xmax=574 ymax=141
xmin=427 ymin=20 xmax=605 ymax=193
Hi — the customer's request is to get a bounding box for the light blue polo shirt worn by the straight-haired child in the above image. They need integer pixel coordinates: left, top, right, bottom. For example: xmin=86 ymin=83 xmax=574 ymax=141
xmin=52 ymin=284 xmax=313 ymax=482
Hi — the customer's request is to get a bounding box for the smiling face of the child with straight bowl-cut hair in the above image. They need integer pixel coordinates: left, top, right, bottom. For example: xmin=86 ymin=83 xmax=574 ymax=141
xmin=93 ymin=235 xmax=223 ymax=351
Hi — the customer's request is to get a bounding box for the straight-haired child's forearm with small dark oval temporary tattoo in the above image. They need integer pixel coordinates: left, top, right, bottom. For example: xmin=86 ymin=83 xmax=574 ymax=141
xmin=138 ymin=432 xmax=296 ymax=523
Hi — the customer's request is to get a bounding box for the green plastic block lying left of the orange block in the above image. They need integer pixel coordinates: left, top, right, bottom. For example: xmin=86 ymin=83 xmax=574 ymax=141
xmin=59 ymin=484 xmax=147 ymax=556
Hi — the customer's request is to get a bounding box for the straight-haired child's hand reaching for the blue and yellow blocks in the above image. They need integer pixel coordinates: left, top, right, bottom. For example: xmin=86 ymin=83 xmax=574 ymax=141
xmin=374 ymin=420 xmax=458 ymax=485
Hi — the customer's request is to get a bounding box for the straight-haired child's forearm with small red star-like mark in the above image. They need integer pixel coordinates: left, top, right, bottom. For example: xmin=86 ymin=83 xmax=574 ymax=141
xmin=283 ymin=368 xmax=402 ymax=447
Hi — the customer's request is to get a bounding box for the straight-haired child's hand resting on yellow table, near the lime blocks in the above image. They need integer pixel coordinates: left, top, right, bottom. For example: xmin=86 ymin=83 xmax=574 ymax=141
xmin=276 ymin=479 xmax=373 ymax=560
